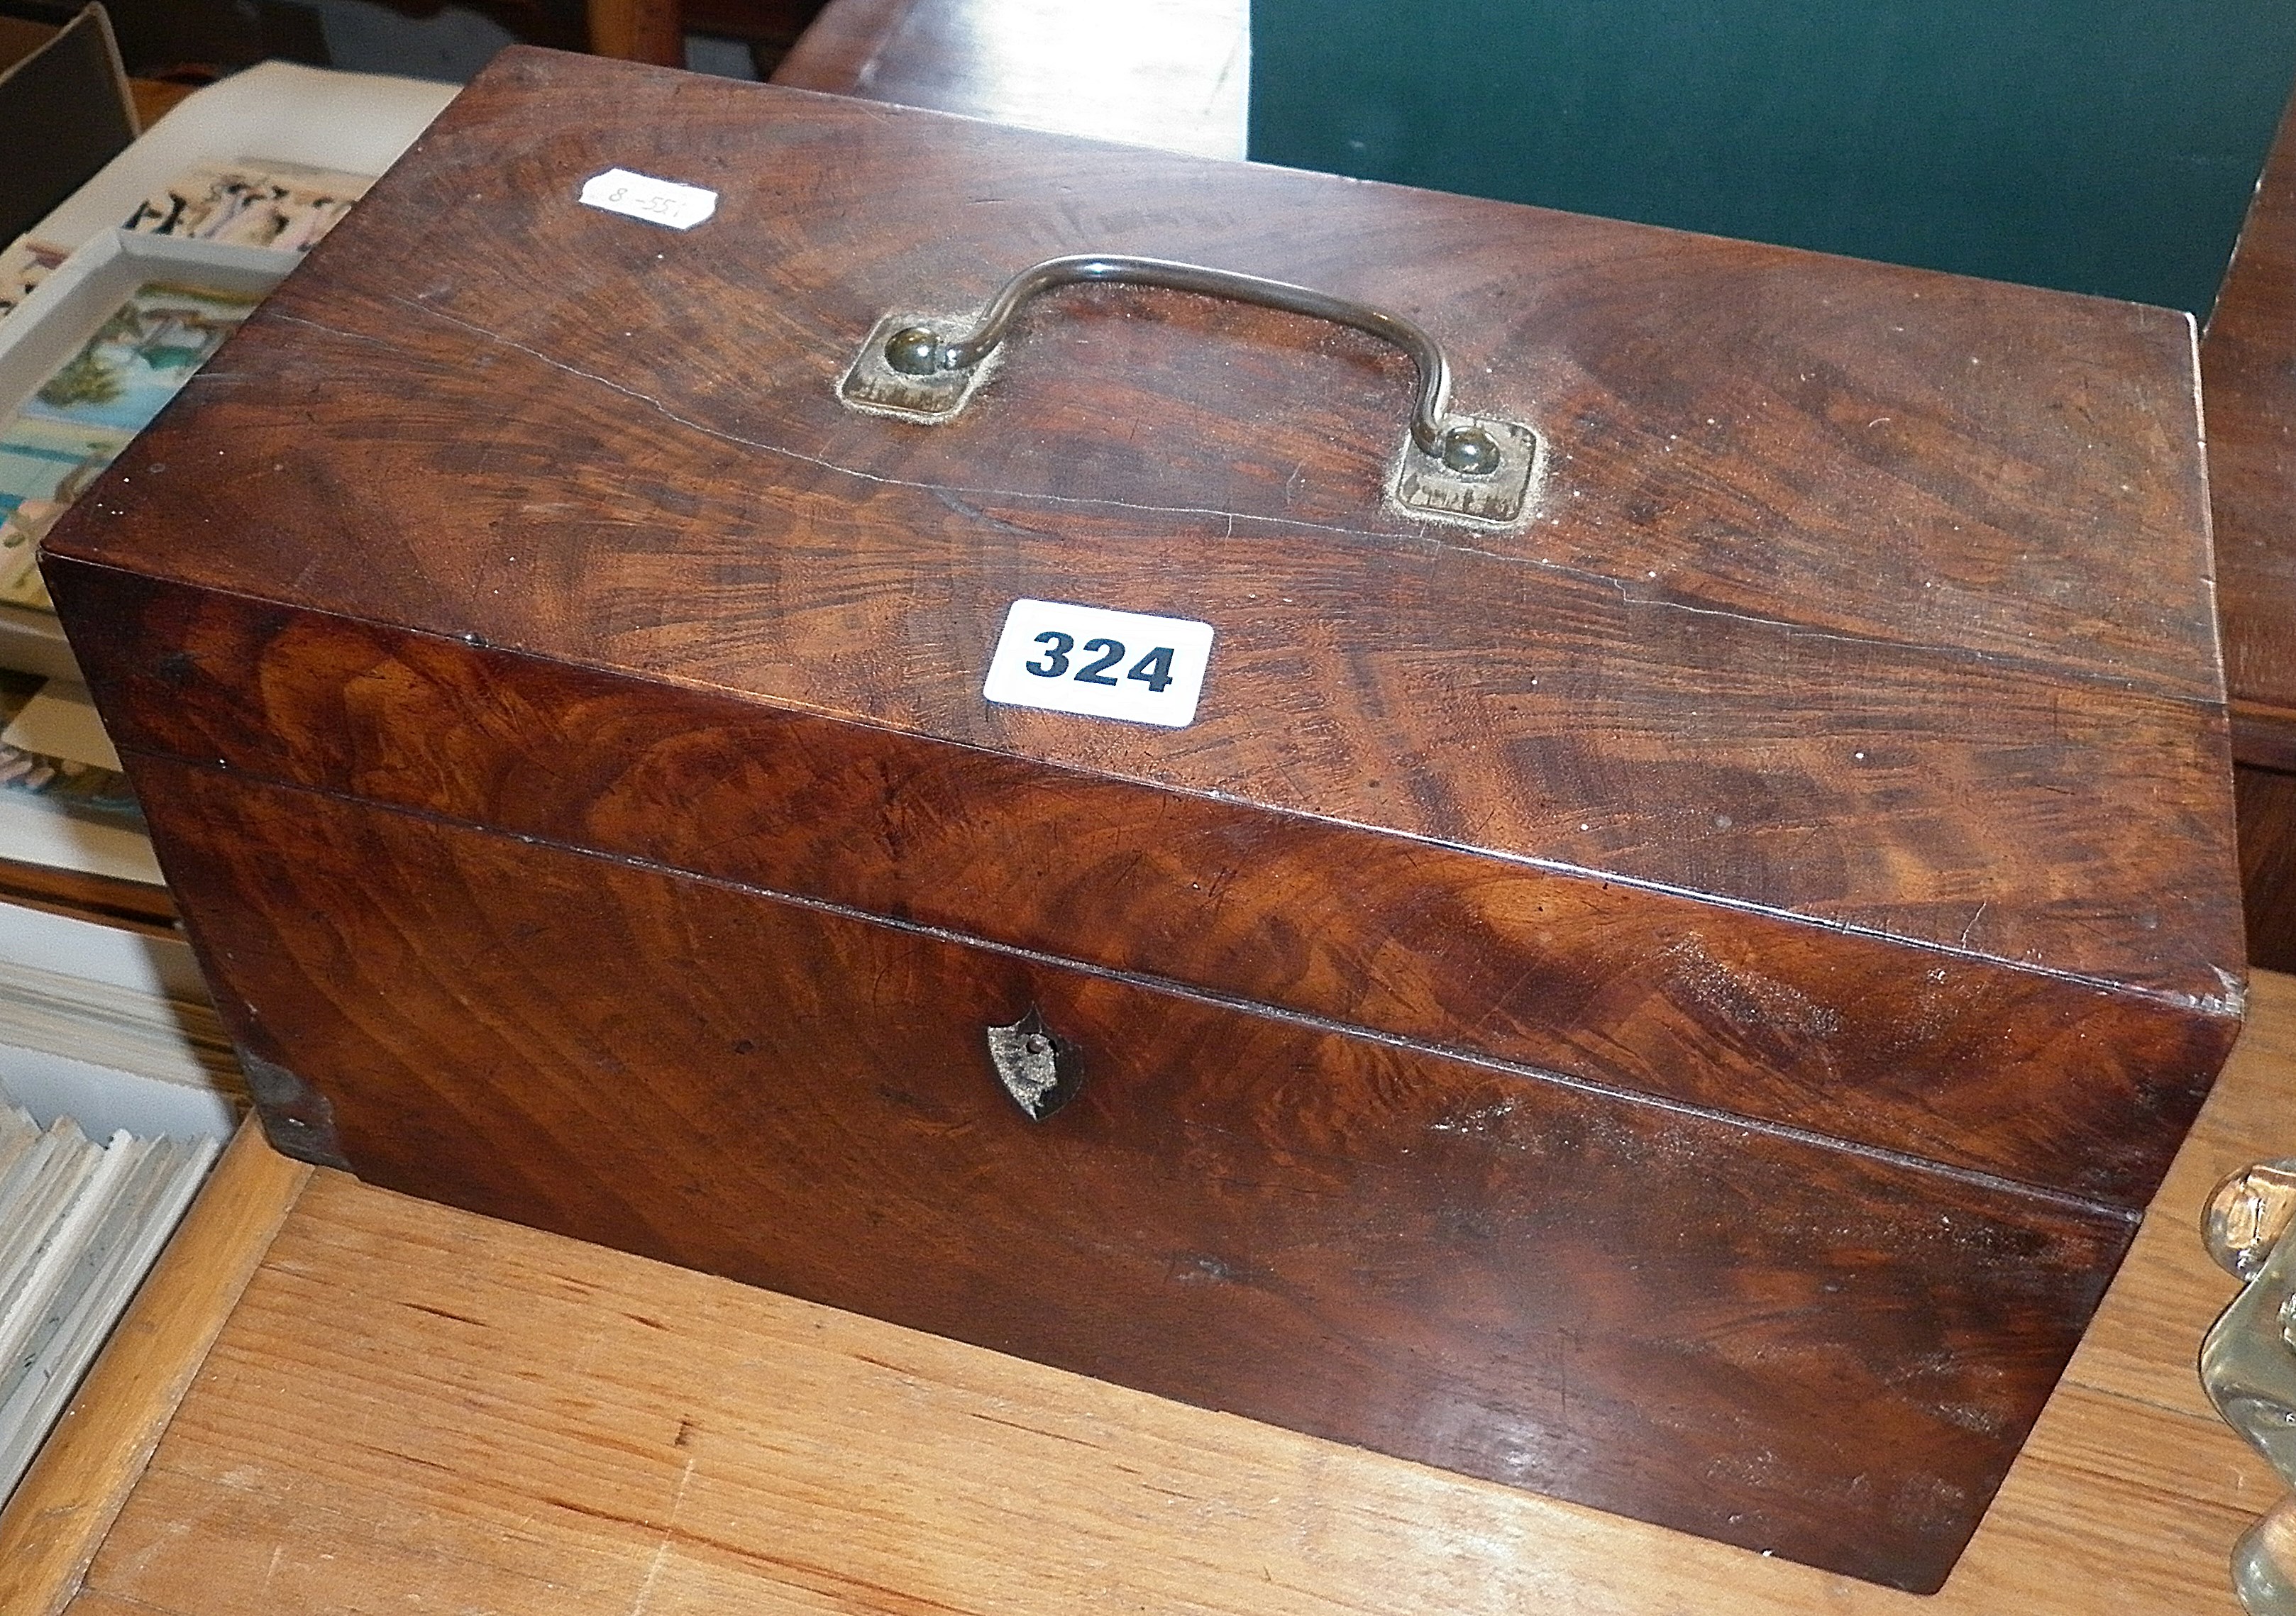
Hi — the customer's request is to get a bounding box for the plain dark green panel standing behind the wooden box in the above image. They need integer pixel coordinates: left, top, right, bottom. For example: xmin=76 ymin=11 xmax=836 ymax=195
xmin=1252 ymin=0 xmax=2296 ymax=312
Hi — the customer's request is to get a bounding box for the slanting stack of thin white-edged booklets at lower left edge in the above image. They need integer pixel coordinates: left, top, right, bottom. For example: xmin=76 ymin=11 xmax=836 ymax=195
xmin=0 ymin=1097 xmax=218 ymax=1499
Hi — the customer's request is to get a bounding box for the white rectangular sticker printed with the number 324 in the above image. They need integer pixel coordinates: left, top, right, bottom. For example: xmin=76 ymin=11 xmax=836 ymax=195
xmin=981 ymin=602 xmax=1213 ymax=730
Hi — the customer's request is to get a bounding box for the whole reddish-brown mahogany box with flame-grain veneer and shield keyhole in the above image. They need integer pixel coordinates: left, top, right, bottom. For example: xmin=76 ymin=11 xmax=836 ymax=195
xmin=46 ymin=50 xmax=2241 ymax=1588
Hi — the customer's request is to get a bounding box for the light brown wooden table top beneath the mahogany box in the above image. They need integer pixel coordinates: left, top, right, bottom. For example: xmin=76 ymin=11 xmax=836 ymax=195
xmin=0 ymin=975 xmax=2296 ymax=1616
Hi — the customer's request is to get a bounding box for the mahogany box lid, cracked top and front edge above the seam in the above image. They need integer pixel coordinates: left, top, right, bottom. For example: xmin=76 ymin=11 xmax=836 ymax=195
xmin=48 ymin=48 xmax=2243 ymax=1205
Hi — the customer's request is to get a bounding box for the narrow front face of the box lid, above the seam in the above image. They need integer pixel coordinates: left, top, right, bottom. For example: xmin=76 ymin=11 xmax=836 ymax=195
xmin=48 ymin=573 xmax=2227 ymax=1205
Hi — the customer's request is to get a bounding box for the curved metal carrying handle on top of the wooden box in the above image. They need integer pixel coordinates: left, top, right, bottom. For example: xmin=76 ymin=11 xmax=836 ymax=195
xmin=884 ymin=253 xmax=1499 ymax=477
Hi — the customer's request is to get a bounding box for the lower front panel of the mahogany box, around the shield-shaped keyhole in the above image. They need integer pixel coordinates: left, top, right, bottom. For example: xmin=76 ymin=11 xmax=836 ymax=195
xmin=138 ymin=758 xmax=2135 ymax=1584
